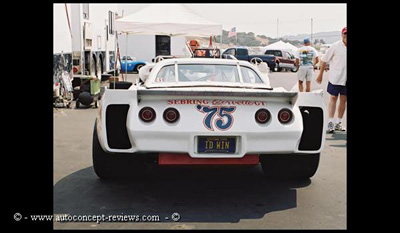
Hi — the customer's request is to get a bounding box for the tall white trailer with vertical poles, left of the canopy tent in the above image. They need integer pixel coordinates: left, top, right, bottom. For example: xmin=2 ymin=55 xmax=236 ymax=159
xmin=70 ymin=3 xmax=118 ymax=79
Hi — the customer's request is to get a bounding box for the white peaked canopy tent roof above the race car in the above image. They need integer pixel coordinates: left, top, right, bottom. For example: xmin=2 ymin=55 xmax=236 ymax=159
xmin=115 ymin=4 xmax=222 ymax=36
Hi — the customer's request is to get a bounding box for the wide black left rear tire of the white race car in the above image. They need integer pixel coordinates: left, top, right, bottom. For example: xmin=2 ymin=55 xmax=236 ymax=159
xmin=92 ymin=121 xmax=145 ymax=180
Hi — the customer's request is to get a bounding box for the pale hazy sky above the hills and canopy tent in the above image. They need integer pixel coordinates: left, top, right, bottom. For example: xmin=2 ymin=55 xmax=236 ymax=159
xmin=119 ymin=3 xmax=347 ymax=38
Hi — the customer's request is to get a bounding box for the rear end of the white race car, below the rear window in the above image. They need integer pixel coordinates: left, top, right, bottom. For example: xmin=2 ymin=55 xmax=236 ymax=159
xmin=94 ymin=88 xmax=325 ymax=177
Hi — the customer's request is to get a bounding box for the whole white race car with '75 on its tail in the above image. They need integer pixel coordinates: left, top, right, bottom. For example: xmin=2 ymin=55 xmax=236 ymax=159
xmin=93 ymin=58 xmax=326 ymax=178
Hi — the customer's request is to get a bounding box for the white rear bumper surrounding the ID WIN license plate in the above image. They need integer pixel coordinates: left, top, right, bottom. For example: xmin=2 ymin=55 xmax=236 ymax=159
xmin=128 ymin=128 xmax=302 ymax=158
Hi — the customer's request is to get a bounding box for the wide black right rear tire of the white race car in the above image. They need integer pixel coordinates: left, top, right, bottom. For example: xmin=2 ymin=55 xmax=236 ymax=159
xmin=260 ymin=153 xmax=320 ymax=179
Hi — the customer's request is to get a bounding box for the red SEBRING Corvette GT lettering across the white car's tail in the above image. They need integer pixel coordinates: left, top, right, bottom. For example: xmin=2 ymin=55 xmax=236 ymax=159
xmin=167 ymin=100 xmax=266 ymax=106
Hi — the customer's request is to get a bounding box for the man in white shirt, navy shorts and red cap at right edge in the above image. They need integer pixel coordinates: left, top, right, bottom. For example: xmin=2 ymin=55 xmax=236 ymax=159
xmin=316 ymin=27 xmax=347 ymax=133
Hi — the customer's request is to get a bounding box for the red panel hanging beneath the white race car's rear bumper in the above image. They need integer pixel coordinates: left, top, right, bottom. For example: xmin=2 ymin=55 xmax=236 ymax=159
xmin=158 ymin=153 xmax=259 ymax=165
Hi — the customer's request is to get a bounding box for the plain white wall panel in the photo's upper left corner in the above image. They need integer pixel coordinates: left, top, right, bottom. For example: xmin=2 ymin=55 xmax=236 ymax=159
xmin=53 ymin=3 xmax=72 ymax=53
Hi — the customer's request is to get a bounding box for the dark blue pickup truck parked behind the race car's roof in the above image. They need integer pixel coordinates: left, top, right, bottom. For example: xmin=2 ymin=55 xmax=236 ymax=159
xmin=222 ymin=48 xmax=276 ymax=70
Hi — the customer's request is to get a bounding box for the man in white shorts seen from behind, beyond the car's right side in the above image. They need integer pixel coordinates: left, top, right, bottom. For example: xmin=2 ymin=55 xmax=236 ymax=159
xmin=296 ymin=38 xmax=318 ymax=92
